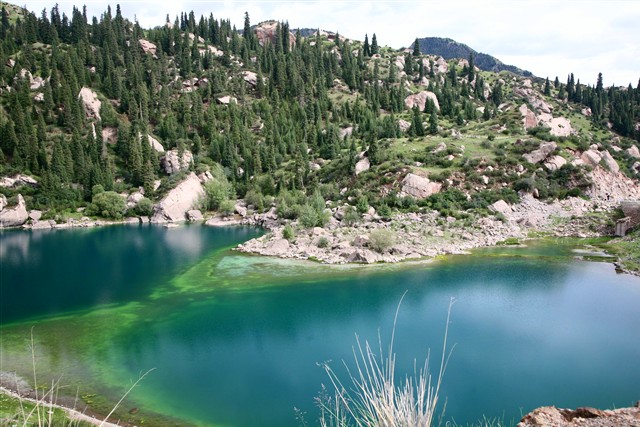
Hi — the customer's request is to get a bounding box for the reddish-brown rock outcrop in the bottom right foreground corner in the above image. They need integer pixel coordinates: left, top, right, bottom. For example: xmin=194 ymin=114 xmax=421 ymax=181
xmin=518 ymin=406 xmax=640 ymax=427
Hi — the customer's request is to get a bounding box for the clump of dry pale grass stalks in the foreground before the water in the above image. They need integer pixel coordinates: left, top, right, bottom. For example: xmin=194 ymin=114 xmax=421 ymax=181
xmin=317 ymin=292 xmax=454 ymax=427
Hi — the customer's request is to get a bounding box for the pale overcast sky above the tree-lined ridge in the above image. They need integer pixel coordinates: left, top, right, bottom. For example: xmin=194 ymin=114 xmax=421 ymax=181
xmin=25 ymin=0 xmax=640 ymax=87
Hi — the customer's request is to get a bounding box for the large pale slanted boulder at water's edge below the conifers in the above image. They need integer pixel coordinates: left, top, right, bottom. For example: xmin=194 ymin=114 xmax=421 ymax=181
xmin=151 ymin=172 xmax=204 ymax=223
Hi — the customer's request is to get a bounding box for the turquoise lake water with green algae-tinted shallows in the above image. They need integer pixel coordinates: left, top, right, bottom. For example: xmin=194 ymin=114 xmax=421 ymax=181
xmin=0 ymin=226 xmax=640 ymax=427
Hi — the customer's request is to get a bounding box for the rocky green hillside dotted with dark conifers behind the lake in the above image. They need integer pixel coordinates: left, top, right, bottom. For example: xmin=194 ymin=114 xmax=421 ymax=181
xmin=0 ymin=2 xmax=640 ymax=260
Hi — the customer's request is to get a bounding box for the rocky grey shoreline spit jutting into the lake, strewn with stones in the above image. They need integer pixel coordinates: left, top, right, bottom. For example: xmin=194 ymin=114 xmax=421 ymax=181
xmin=232 ymin=195 xmax=614 ymax=264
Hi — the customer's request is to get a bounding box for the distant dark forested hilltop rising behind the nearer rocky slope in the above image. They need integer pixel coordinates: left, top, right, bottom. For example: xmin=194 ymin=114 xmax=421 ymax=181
xmin=409 ymin=37 xmax=532 ymax=77
